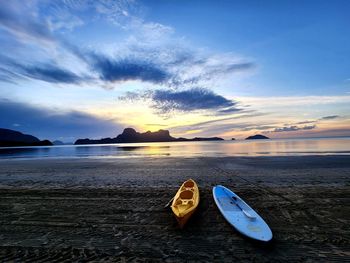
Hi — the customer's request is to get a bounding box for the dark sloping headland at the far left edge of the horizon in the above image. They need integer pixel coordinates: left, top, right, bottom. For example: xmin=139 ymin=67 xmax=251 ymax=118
xmin=0 ymin=128 xmax=52 ymax=147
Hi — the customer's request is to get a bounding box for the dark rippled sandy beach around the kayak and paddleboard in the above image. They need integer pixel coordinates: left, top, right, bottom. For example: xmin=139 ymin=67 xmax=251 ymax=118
xmin=0 ymin=156 xmax=350 ymax=262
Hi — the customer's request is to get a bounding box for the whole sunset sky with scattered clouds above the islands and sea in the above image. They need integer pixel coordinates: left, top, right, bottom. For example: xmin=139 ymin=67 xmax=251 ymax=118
xmin=0 ymin=0 xmax=350 ymax=142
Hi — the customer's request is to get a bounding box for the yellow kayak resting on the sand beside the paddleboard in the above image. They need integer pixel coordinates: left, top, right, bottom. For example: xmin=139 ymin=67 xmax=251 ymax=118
xmin=171 ymin=179 xmax=199 ymax=228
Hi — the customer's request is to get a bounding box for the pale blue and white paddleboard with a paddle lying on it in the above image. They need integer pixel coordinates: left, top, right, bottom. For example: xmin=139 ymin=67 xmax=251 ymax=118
xmin=213 ymin=185 xmax=272 ymax=242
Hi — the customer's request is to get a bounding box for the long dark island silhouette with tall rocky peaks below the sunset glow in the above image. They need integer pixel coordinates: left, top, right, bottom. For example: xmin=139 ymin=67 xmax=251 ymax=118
xmin=74 ymin=128 xmax=224 ymax=145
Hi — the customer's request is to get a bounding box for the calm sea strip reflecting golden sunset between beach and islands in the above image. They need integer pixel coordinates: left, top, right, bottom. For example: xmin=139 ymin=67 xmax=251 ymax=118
xmin=0 ymin=138 xmax=350 ymax=159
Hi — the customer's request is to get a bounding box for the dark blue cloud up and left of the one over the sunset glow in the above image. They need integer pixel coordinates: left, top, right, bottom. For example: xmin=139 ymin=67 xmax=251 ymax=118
xmin=91 ymin=55 xmax=169 ymax=83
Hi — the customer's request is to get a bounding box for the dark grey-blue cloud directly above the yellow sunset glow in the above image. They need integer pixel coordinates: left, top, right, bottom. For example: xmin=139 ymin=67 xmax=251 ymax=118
xmin=119 ymin=88 xmax=241 ymax=115
